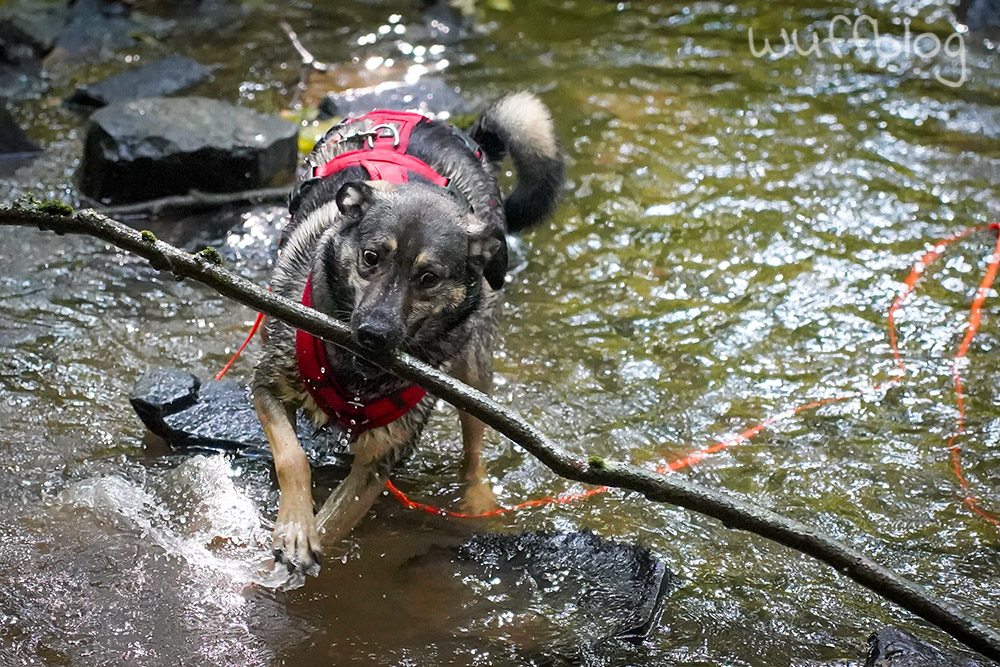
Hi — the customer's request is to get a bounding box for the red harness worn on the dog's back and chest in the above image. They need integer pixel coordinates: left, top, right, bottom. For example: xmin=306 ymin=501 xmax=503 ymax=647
xmin=295 ymin=111 xmax=449 ymax=440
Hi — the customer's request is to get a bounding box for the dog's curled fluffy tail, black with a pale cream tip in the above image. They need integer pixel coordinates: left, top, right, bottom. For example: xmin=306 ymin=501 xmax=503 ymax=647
xmin=469 ymin=91 xmax=566 ymax=232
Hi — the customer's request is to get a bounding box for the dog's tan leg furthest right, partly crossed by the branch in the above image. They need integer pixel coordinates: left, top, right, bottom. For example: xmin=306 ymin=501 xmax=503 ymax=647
xmin=452 ymin=336 xmax=497 ymax=514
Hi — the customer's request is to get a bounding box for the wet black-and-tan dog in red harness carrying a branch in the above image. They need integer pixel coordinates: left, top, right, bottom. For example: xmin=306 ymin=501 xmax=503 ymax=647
xmin=252 ymin=92 xmax=565 ymax=574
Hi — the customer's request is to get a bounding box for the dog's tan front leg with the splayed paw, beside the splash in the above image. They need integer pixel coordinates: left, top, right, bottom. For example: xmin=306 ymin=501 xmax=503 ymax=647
xmin=253 ymin=387 xmax=320 ymax=574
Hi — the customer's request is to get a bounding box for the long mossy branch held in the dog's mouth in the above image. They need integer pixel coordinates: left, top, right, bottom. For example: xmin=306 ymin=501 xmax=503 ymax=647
xmin=0 ymin=202 xmax=1000 ymax=663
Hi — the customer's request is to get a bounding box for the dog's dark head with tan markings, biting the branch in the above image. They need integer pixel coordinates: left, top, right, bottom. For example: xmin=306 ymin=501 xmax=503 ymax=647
xmin=326 ymin=181 xmax=507 ymax=368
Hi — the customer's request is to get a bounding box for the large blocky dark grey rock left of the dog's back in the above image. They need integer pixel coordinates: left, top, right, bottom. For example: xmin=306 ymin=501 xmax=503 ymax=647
xmin=78 ymin=97 xmax=298 ymax=203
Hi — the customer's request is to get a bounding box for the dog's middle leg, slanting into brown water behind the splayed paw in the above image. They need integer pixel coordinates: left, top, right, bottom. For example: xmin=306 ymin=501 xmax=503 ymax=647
xmin=316 ymin=428 xmax=407 ymax=545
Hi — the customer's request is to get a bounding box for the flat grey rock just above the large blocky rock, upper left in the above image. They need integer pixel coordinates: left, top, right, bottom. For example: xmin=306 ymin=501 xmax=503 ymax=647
xmin=66 ymin=56 xmax=212 ymax=107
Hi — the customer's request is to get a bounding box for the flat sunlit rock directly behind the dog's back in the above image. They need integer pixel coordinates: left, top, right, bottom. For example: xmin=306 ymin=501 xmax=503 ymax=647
xmin=319 ymin=77 xmax=475 ymax=118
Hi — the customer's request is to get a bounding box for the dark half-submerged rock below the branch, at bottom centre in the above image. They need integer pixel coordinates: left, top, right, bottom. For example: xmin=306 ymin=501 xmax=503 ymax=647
xmin=410 ymin=531 xmax=679 ymax=664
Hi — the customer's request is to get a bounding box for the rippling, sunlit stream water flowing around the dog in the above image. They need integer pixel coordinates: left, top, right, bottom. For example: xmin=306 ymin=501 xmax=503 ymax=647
xmin=0 ymin=0 xmax=1000 ymax=666
